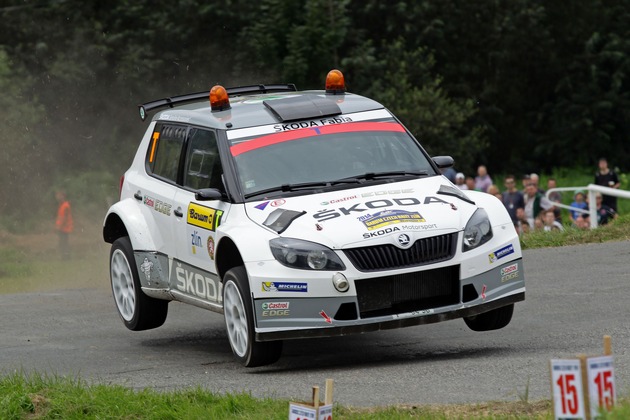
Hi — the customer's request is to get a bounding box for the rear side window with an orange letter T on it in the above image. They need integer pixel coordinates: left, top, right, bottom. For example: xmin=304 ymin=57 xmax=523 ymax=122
xmin=147 ymin=125 xmax=187 ymax=182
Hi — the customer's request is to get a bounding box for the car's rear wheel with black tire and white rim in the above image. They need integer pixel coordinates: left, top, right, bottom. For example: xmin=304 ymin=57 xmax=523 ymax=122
xmin=109 ymin=236 xmax=168 ymax=331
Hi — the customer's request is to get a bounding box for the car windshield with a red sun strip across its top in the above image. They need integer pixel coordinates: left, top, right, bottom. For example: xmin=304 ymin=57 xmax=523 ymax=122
xmin=231 ymin=122 xmax=436 ymax=197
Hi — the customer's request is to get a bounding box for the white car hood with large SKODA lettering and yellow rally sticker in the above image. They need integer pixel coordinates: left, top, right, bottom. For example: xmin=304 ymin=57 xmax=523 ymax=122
xmin=245 ymin=176 xmax=477 ymax=249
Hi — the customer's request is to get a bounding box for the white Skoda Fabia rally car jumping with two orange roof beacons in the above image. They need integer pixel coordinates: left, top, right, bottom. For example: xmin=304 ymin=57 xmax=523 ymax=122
xmin=103 ymin=70 xmax=525 ymax=366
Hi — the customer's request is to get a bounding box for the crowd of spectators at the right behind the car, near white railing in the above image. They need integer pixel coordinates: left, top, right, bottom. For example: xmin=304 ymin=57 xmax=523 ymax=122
xmin=445 ymin=158 xmax=620 ymax=234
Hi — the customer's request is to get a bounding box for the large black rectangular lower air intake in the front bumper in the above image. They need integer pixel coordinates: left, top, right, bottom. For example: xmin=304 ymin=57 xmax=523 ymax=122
xmin=354 ymin=265 xmax=460 ymax=318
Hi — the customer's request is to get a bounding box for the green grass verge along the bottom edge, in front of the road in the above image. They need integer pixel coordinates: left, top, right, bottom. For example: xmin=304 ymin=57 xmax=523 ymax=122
xmin=0 ymin=372 xmax=551 ymax=420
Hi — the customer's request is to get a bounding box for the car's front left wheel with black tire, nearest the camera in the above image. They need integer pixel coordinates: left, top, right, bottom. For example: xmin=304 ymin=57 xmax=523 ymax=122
xmin=223 ymin=266 xmax=282 ymax=367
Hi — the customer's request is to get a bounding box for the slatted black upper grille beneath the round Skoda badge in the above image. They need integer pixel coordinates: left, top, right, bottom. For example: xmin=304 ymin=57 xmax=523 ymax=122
xmin=343 ymin=232 xmax=457 ymax=271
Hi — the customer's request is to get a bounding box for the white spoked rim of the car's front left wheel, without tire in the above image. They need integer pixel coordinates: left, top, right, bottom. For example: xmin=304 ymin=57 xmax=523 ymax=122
xmin=223 ymin=280 xmax=249 ymax=357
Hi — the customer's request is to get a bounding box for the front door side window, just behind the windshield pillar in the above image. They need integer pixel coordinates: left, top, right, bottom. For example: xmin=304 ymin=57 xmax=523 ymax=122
xmin=184 ymin=128 xmax=223 ymax=190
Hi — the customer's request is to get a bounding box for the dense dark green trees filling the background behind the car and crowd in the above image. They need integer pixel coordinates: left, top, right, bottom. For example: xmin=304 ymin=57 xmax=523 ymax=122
xmin=0 ymin=0 xmax=630 ymax=217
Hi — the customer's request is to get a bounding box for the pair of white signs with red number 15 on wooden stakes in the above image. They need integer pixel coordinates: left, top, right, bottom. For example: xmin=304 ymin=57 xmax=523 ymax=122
xmin=550 ymin=335 xmax=616 ymax=420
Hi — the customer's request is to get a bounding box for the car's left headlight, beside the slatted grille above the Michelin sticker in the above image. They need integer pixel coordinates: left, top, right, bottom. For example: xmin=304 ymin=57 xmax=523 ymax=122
xmin=269 ymin=238 xmax=346 ymax=270
